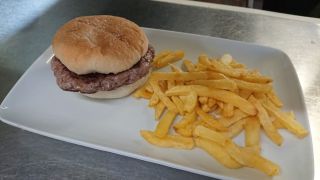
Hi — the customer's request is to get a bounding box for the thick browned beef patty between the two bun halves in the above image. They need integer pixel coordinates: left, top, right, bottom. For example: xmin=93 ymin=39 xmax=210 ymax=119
xmin=51 ymin=45 xmax=155 ymax=94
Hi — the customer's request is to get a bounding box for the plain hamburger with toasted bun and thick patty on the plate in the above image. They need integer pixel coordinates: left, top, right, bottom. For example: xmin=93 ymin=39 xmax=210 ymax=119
xmin=51 ymin=15 xmax=155 ymax=98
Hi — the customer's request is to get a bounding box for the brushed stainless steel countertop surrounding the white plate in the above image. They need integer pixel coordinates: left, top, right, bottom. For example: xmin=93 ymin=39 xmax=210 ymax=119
xmin=0 ymin=0 xmax=320 ymax=179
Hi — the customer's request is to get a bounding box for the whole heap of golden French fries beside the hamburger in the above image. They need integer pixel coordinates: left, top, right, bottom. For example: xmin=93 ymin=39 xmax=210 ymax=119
xmin=133 ymin=50 xmax=308 ymax=176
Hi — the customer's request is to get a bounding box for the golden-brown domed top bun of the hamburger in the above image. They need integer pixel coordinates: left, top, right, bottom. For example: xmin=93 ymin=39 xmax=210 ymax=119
xmin=52 ymin=15 xmax=148 ymax=75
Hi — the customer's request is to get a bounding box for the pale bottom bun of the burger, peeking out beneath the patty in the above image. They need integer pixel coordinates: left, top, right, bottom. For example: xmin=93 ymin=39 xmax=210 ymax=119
xmin=81 ymin=73 xmax=150 ymax=99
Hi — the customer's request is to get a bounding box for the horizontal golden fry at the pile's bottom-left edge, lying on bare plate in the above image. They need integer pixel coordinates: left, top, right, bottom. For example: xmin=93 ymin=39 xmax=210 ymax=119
xmin=140 ymin=130 xmax=194 ymax=149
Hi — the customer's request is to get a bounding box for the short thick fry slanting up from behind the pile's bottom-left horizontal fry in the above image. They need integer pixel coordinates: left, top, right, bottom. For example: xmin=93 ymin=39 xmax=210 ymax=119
xmin=154 ymin=111 xmax=177 ymax=138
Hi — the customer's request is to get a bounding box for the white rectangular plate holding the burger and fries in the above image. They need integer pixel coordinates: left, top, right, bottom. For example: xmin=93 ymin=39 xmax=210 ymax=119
xmin=0 ymin=28 xmax=313 ymax=180
